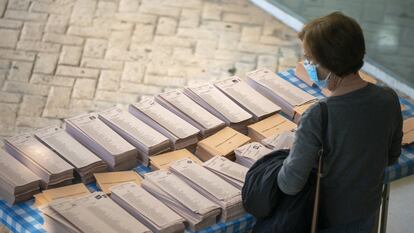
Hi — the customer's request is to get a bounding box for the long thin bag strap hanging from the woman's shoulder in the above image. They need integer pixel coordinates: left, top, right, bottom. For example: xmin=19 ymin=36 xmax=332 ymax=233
xmin=311 ymin=101 xmax=328 ymax=233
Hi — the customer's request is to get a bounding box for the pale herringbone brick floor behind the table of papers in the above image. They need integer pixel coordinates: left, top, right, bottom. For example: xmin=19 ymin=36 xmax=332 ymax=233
xmin=0 ymin=0 xmax=300 ymax=142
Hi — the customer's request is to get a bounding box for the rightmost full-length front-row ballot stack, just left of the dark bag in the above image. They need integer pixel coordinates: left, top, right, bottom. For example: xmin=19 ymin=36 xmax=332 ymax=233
xmin=170 ymin=159 xmax=245 ymax=222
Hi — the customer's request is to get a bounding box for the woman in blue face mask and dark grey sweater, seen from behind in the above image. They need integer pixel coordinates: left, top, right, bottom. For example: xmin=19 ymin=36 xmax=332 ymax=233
xmin=277 ymin=12 xmax=403 ymax=233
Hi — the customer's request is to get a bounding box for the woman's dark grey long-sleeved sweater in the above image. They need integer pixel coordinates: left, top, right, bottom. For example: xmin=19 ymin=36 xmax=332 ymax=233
xmin=277 ymin=84 xmax=403 ymax=227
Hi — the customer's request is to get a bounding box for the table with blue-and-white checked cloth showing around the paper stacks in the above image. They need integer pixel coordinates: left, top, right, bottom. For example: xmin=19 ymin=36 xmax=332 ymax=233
xmin=0 ymin=70 xmax=414 ymax=233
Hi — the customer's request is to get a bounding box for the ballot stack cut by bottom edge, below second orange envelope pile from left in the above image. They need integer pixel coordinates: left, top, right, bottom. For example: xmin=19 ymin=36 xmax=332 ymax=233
xmin=111 ymin=183 xmax=185 ymax=233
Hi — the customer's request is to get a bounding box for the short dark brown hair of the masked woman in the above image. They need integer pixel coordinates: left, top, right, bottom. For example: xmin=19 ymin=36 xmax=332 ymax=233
xmin=298 ymin=12 xmax=365 ymax=77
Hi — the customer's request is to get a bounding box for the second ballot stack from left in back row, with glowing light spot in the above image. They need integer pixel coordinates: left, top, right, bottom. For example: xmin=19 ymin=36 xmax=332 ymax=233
xmin=5 ymin=134 xmax=74 ymax=189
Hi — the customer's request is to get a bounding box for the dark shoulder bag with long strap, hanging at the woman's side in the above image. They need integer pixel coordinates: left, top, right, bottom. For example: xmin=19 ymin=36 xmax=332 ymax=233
xmin=242 ymin=102 xmax=328 ymax=233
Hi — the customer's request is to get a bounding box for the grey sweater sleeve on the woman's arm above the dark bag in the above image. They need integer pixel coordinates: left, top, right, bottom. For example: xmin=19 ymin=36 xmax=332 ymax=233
xmin=277 ymin=104 xmax=322 ymax=195
